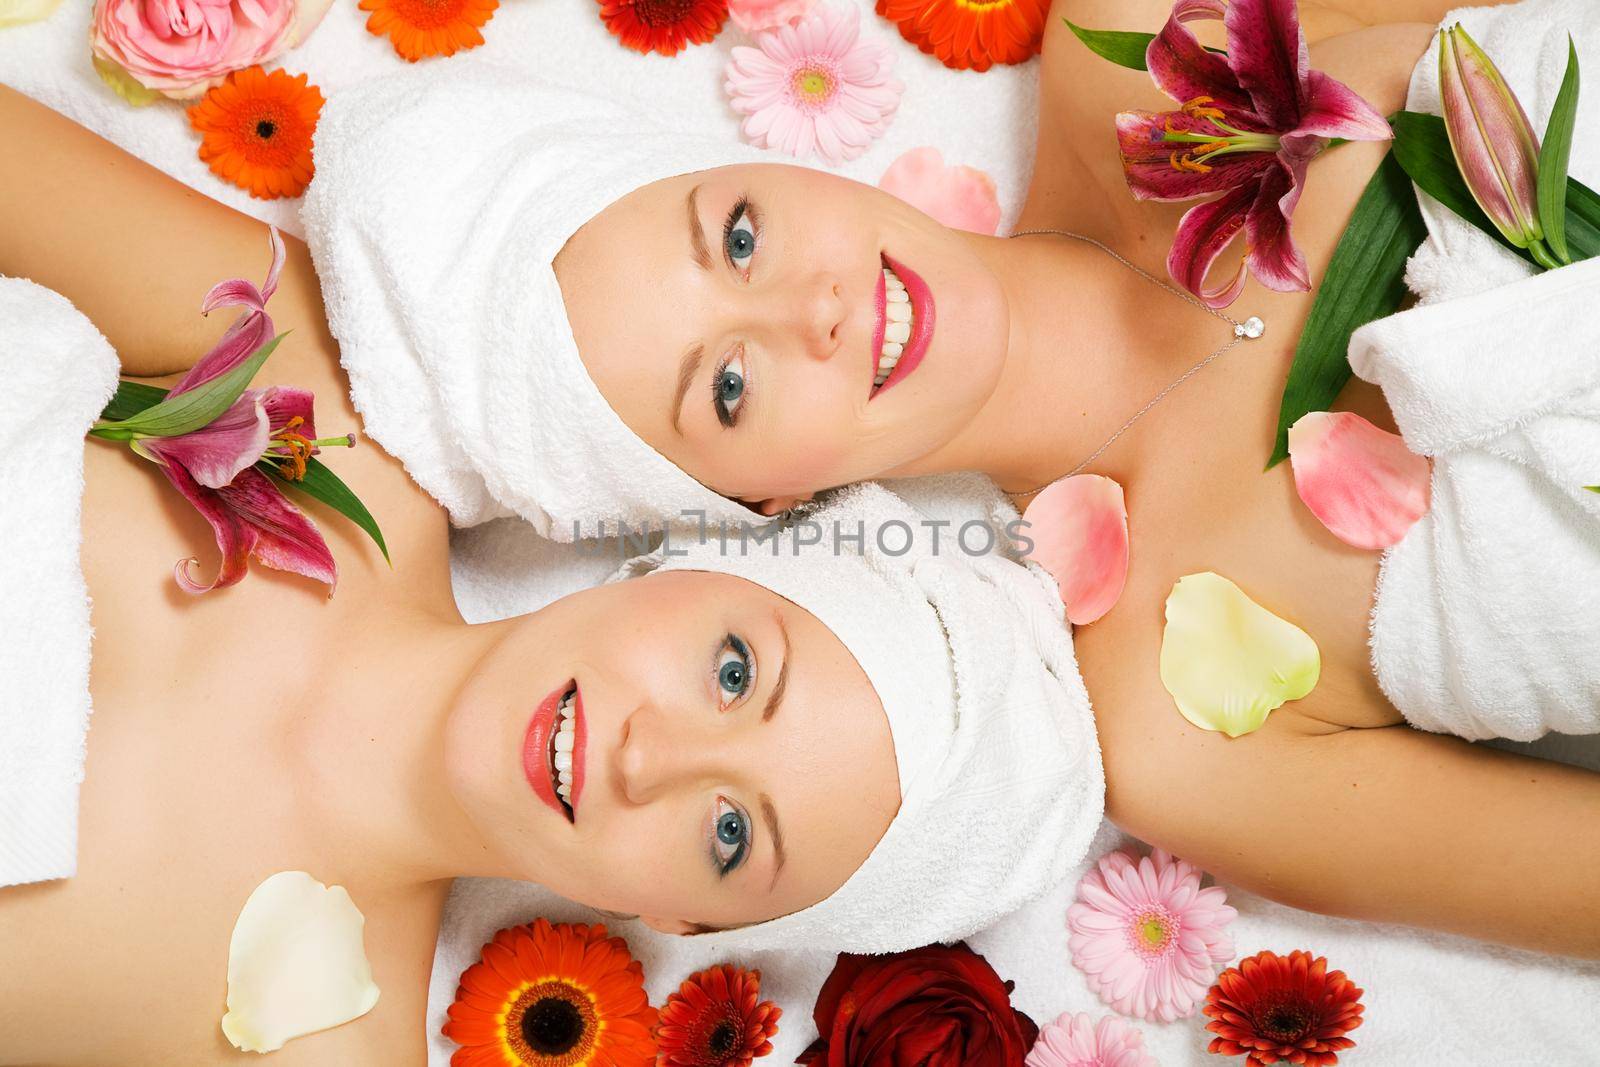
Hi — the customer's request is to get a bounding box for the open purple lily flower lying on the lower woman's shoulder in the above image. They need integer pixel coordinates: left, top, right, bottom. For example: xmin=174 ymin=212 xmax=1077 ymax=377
xmin=133 ymin=229 xmax=354 ymax=597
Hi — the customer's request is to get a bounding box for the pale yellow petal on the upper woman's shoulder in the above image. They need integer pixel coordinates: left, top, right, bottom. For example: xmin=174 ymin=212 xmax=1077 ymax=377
xmin=1162 ymin=571 xmax=1322 ymax=737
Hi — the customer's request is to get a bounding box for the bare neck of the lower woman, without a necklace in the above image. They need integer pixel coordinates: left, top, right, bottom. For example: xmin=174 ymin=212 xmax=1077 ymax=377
xmin=285 ymin=611 xmax=506 ymax=889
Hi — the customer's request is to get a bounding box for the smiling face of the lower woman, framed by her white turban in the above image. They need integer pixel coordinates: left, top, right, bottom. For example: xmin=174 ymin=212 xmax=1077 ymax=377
xmin=445 ymin=571 xmax=899 ymax=931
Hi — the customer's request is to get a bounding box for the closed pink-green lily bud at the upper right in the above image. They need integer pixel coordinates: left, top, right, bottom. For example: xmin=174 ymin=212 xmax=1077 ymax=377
xmin=1438 ymin=24 xmax=1554 ymax=255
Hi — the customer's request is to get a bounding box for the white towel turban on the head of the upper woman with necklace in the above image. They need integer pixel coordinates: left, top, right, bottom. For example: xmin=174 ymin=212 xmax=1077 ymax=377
xmin=302 ymin=59 xmax=763 ymax=541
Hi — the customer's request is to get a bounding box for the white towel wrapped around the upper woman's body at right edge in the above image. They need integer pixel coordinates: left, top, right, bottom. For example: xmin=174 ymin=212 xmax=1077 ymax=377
xmin=1349 ymin=0 xmax=1600 ymax=741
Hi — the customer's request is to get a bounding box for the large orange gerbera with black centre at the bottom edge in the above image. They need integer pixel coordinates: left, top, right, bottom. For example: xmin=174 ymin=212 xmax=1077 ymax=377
xmin=445 ymin=918 xmax=656 ymax=1067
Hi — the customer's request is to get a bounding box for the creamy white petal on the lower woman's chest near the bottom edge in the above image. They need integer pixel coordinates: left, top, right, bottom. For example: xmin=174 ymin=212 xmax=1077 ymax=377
xmin=222 ymin=870 xmax=378 ymax=1053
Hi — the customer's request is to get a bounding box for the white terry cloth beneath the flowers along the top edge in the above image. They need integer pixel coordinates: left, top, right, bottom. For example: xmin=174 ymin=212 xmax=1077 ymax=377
xmin=0 ymin=0 xmax=1038 ymax=237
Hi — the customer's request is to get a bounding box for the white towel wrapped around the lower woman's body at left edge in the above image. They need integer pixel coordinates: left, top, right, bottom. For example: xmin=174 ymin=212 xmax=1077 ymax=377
xmin=0 ymin=278 xmax=117 ymax=886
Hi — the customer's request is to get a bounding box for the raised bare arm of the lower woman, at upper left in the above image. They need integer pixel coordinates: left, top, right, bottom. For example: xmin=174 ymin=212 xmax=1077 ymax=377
xmin=0 ymin=85 xmax=276 ymax=378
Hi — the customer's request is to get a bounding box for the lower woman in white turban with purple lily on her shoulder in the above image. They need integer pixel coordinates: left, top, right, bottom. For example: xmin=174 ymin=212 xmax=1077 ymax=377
xmin=0 ymin=251 xmax=1104 ymax=1064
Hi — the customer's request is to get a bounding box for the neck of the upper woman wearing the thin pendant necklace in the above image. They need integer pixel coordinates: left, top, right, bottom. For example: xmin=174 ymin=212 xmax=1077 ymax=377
xmin=934 ymin=235 xmax=1221 ymax=494
